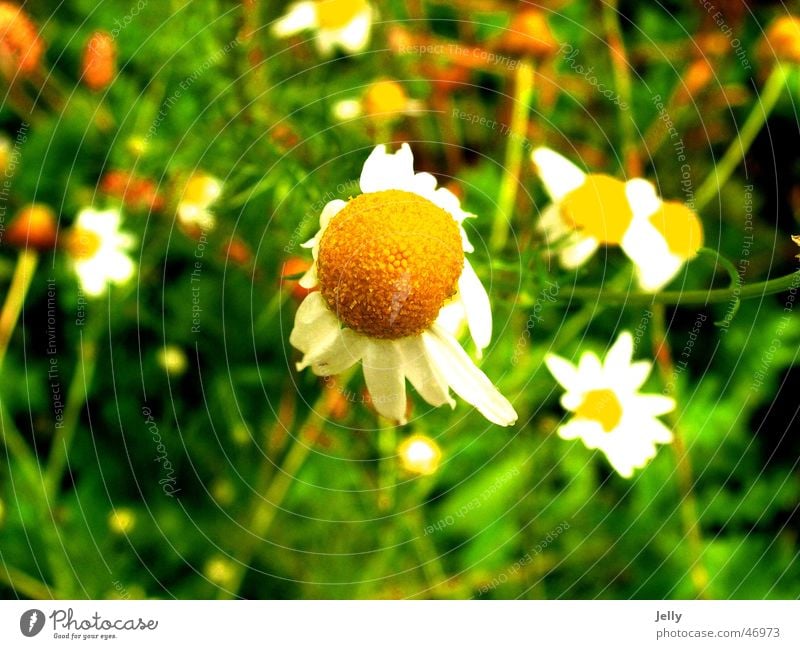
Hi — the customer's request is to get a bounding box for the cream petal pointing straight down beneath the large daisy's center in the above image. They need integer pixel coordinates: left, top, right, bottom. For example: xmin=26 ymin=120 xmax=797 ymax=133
xmin=362 ymin=339 xmax=406 ymax=424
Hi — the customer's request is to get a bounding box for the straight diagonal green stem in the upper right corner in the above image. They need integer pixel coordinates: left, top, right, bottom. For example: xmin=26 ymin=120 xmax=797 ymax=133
xmin=693 ymin=64 xmax=786 ymax=212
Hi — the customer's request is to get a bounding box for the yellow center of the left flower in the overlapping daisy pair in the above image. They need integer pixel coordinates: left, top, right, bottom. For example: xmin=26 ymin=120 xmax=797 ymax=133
xmin=561 ymin=174 xmax=633 ymax=245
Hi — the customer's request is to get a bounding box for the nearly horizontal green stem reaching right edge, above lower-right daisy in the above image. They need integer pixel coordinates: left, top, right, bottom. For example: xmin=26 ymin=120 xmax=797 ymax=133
xmin=557 ymin=270 xmax=800 ymax=306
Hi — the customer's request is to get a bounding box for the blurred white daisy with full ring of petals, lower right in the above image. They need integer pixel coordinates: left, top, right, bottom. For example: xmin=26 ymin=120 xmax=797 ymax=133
xmin=545 ymin=331 xmax=675 ymax=478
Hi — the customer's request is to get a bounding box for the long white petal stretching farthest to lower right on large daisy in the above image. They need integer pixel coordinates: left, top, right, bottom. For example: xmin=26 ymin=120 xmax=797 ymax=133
xmin=422 ymin=324 xmax=517 ymax=426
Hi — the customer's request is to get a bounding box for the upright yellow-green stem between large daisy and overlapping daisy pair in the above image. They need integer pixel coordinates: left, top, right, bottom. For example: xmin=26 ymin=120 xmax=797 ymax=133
xmin=490 ymin=60 xmax=535 ymax=251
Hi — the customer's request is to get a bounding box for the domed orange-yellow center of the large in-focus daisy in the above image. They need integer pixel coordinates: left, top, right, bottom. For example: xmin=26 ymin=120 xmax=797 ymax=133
xmin=317 ymin=189 xmax=464 ymax=339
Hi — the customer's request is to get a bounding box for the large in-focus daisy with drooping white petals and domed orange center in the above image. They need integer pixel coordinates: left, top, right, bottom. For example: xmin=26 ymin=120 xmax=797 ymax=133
xmin=289 ymin=144 xmax=517 ymax=426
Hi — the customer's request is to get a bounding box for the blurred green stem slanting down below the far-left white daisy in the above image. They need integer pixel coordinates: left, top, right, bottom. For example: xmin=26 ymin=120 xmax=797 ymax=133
xmin=44 ymin=319 xmax=104 ymax=502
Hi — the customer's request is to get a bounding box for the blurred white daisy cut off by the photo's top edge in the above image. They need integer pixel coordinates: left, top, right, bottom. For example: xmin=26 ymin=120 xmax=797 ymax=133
xmin=272 ymin=0 xmax=373 ymax=56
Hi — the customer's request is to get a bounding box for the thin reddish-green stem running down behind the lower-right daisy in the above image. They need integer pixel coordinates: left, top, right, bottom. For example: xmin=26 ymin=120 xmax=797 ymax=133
xmin=653 ymin=304 xmax=709 ymax=598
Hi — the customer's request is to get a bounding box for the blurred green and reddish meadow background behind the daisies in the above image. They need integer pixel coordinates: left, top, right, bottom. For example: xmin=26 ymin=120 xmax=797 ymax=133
xmin=0 ymin=0 xmax=800 ymax=599
